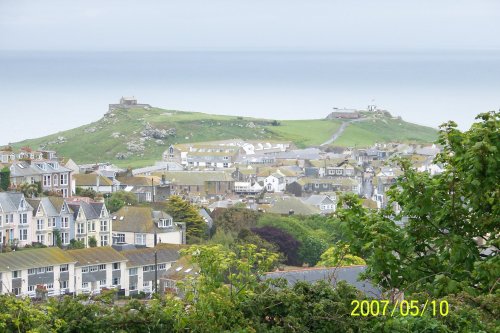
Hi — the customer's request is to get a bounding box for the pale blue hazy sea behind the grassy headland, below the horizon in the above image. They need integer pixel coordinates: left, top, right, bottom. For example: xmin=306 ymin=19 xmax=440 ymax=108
xmin=0 ymin=51 xmax=500 ymax=145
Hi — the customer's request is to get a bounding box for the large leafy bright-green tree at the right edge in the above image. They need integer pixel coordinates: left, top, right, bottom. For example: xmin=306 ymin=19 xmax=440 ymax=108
xmin=337 ymin=112 xmax=500 ymax=296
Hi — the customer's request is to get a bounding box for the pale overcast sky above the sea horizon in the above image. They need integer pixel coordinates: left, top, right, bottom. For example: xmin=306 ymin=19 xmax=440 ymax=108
xmin=0 ymin=0 xmax=500 ymax=51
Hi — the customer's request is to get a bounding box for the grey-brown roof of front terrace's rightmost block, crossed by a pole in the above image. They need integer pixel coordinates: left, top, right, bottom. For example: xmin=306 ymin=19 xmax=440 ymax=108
xmin=121 ymin=244 xmax=183 ymax=267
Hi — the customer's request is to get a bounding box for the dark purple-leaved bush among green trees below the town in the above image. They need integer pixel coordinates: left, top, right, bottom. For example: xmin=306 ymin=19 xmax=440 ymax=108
xmin=251 ymin=227 xmax=303 ymax=266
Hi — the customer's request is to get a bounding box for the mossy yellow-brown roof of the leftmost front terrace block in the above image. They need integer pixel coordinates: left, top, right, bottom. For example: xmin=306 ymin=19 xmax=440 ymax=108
xmin=0 ymin=247 xmax=76 ymax=272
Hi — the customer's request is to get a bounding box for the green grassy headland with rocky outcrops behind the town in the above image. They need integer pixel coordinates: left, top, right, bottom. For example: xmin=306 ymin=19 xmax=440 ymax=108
xmin=13 ymin=108 xmax=436 ymax=167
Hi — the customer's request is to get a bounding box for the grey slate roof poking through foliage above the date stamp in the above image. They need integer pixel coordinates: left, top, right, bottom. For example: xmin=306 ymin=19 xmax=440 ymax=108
xmin=264 ymin=266 xmax=382 ymax=296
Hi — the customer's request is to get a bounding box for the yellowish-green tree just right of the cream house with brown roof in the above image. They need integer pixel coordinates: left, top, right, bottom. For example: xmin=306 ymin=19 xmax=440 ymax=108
xmin=166 ymin=195 xmax=207 ymax=243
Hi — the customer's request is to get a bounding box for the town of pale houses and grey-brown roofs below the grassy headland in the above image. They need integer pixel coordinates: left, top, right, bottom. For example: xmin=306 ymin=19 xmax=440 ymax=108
xmin=0 ymin=98 xmax=443 ymax=298
